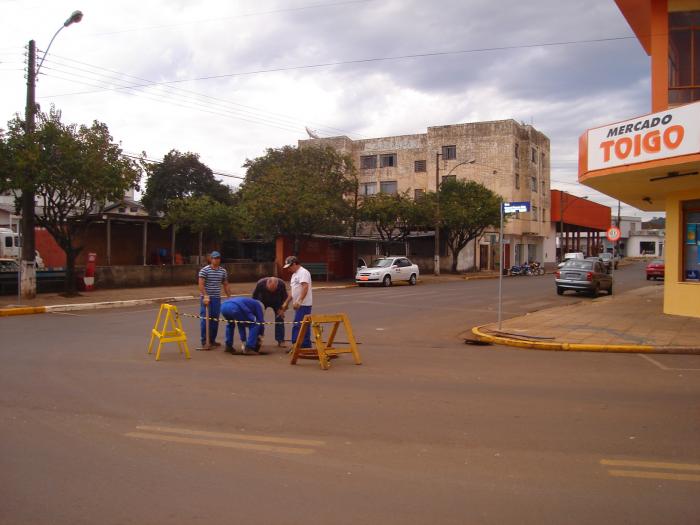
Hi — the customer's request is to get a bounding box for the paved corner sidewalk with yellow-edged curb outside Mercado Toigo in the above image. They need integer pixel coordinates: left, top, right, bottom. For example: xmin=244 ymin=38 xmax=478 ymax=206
xmin=472 ymin=285 xmax=700 ymax=354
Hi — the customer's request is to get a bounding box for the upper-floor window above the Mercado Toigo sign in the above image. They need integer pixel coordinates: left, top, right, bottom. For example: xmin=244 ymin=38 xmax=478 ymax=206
xmin=668 ymin=10 xmax=700 ymax=105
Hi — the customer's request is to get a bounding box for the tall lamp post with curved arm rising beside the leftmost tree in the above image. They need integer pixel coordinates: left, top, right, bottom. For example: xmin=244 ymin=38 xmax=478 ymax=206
xmin=19 ymin=11 xmax=83 ymax=299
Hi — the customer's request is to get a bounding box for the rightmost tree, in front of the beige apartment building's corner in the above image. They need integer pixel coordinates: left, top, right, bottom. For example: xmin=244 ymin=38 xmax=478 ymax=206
xmin=439 ymin=180 xmax=501 ymax=273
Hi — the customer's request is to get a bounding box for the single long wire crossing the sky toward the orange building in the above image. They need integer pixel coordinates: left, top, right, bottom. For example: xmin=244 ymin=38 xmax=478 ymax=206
xmin=39 ymin=36 xmax=637 ymax=97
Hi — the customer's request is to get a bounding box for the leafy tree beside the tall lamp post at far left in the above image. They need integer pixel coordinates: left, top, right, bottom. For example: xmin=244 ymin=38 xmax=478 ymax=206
xmin=2 ymin=108 xmax=141 ymax=295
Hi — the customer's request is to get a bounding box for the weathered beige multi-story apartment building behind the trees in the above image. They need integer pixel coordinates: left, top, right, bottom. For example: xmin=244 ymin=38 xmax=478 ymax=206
xmin=299 ymin=120 xmax=554 ymax=270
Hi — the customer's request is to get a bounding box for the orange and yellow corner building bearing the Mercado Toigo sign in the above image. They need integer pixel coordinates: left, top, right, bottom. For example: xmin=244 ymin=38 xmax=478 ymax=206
xmin=579 ymin=0 xmax=700 ymax=317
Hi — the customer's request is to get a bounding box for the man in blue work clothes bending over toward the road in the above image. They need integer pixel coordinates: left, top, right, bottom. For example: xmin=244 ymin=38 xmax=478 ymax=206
xmin=221 ymin=297 xmax=265 ymax=354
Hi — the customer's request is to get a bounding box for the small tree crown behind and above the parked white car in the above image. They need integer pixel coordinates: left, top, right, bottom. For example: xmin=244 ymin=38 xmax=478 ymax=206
xmin=360 ymin=193 xmax=434 ymax=250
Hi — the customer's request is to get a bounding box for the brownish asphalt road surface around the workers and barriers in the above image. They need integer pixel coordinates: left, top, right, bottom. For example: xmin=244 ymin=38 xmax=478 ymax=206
xmin=0 ymin=265 xmax=700 ymax=524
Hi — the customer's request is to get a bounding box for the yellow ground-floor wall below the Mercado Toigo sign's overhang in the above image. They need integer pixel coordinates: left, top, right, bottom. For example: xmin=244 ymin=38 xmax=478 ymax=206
xmin=664 ymin=188 xmax=700 ymax=317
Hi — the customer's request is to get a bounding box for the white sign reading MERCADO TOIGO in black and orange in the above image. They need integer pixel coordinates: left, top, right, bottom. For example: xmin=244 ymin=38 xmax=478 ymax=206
xmin=588 ymin=102 xmax=700 ymax=171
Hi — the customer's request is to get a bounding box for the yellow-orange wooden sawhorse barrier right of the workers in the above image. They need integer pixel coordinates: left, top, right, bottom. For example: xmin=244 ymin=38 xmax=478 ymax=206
xmin=291 ymin=314 xmax=362 ymax=370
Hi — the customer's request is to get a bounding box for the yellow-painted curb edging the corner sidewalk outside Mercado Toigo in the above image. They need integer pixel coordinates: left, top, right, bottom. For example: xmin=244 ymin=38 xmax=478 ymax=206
xmin=472 ymin=325 xmax=700 ymax=355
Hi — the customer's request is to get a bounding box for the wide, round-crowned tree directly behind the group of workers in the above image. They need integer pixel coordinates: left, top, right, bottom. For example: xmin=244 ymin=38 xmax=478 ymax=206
xmin=236 ymin=146 xmax=357 ymax=253
